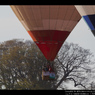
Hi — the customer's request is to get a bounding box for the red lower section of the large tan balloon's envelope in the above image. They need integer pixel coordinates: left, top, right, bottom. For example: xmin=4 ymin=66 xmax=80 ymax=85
xmin=28 ymin=30 xmax=70 ymax=61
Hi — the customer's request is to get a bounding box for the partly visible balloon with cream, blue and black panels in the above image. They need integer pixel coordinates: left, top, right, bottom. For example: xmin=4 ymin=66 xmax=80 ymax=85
xmin=75 ymin=5 xmax=95 ymax=36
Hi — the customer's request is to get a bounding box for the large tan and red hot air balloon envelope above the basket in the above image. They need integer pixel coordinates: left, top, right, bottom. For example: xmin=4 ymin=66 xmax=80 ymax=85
xmin=10 ymin=5 xmax=81 ymax=61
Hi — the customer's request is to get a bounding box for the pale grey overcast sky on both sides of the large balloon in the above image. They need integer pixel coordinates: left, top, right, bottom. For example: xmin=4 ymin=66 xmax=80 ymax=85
xmin=0 ymin=5 xmax=95 ymax=55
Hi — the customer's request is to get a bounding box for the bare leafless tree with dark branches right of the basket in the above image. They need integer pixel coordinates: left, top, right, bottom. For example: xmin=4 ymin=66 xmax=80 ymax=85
xmin=55 ymin=42 xmax=93 ymax=89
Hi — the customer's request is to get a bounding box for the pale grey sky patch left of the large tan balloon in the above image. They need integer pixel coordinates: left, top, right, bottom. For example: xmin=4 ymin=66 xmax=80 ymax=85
xmin=0 ymin=5 xmax=31 ymax=42
